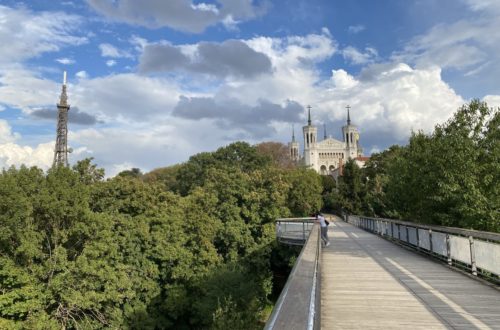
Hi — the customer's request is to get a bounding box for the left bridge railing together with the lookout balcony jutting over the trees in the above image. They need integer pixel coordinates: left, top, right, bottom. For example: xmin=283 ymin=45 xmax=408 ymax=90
xmin=264 ymin=218 xmax=321 ymax=330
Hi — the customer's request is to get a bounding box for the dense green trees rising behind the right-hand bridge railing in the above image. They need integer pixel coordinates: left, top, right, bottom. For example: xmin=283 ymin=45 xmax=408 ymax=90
xmin=332 ymin=100 xmax=500 ymax=232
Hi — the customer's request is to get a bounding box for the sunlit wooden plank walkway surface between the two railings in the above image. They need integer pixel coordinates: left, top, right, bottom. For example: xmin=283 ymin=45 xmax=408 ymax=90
xmin=321 ymin=220 xmax=500 ymax=329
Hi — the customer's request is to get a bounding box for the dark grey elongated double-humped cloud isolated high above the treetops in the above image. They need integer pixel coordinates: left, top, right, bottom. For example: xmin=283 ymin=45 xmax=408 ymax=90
xmin=139 ymin=40 xmax=271 ymax=77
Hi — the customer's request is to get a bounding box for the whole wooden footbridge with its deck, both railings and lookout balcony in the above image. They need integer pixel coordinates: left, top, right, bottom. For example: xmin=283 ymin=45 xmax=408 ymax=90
xmin=266 ymin=216 xmax=500 ymax=329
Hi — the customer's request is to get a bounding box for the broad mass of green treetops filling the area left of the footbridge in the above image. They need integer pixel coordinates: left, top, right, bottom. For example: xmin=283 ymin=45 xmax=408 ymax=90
xmin=0 ymin=143 xmax=322 ymax=329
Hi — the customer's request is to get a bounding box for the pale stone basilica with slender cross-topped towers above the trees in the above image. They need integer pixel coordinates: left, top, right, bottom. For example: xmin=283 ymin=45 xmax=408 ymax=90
xmin=288 ymin=106 xmax=366 ymax=175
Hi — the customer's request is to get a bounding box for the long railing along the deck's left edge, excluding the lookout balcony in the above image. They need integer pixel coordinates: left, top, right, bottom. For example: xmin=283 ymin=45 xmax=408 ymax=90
xmin=264 ymin=218 xmax=321 ymax=330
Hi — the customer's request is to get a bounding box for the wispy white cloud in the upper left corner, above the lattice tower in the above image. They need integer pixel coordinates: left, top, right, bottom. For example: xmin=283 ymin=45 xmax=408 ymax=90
xmin=0 ymin=5 xmax=87 ymax=64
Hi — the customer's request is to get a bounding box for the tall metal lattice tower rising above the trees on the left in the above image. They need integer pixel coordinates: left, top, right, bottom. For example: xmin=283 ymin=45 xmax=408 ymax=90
xmin=53 ymin=71 xmax=69 ymax=166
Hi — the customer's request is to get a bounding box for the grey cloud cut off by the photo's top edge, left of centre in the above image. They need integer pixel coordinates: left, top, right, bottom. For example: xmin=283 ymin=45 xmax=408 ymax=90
xmin=87 ymin=0 xmax=268 ymax=33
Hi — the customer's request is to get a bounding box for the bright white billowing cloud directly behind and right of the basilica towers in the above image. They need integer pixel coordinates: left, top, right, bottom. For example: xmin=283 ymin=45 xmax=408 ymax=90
xmin=321 ymin=63 xmax=464 ymax=144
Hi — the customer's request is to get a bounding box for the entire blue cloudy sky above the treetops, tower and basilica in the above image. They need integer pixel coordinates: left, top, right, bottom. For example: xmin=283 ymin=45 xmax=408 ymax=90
xmin=0 ymin=0 xmax=500 ymax=176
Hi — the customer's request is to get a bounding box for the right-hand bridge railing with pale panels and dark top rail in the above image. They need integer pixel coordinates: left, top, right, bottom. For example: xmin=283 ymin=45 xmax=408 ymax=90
xmin=344 ymin=215 xmax=500 ymax=284
